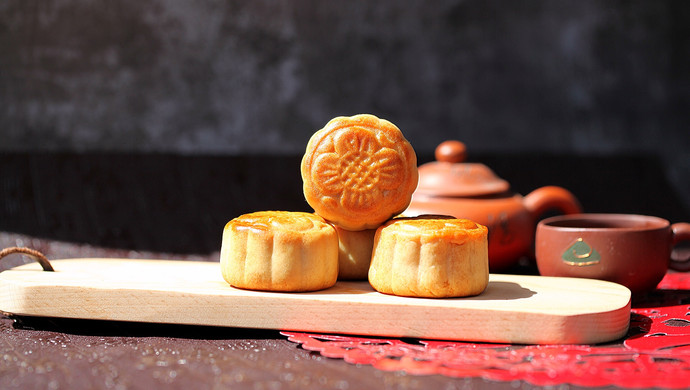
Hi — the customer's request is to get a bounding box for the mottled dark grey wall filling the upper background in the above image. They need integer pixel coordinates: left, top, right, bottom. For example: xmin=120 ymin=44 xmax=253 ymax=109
xmin=0 ymin=0 xmax=690 ymax=213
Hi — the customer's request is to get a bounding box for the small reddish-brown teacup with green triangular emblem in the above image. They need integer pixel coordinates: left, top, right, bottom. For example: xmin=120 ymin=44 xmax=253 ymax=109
xmin=535 ymin=214 xmax=690 ymax=293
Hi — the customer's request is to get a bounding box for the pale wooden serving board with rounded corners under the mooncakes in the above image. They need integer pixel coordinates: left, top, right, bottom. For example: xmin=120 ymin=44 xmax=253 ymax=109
xmin=0 ymin=259 xmax=631 ymax=344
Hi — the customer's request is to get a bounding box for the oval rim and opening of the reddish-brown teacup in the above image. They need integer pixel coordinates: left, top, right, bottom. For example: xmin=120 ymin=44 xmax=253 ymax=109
xmin=538 ymin=213 xmax=670 ymax=231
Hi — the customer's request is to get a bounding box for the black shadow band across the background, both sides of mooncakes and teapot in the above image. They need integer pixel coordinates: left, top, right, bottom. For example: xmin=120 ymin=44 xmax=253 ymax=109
xmin=0 ymin=153 xmax=690 ymax=253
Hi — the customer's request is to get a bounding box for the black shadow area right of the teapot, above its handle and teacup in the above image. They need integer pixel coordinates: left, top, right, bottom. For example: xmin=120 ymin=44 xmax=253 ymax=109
xmin=472 ymin=154 xmax=690 ymax=222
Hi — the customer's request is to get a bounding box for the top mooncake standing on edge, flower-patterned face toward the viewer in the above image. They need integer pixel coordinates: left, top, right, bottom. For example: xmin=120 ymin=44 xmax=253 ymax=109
xmin=301 ymin=114 xmax=418 ymax=230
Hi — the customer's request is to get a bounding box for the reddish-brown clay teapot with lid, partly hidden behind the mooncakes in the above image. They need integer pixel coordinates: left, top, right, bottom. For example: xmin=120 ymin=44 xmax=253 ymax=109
xmin=403 ymin=141 xmax=582 ymax=272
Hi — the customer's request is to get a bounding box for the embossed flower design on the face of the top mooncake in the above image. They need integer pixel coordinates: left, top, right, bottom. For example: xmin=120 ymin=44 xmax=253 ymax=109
xmin=312 ymin=128 xmax=404 ymax=210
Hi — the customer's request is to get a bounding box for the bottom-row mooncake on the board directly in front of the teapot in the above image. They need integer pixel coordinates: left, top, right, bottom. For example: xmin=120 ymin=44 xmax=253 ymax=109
xmin=369 ymin=216 xmax=489 ymax=298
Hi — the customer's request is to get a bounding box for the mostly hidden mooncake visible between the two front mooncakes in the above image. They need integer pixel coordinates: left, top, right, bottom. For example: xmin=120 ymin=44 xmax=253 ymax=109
xmin=335 ymin=226 xmax=376 ymax=280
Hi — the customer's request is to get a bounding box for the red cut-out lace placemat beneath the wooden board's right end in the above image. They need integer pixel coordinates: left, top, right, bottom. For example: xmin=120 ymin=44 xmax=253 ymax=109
xmin=282 ymin=273 xmax=690 ymax=389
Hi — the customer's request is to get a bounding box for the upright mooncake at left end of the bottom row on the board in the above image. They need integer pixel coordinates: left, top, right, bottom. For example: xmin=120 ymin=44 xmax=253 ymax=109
xmin=220 ymin=211 xmax=338 ymax=291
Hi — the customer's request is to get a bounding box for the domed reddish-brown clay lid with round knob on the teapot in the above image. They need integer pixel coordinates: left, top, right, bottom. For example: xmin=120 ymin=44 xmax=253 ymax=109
xmin=417 ymin=141 xmax=510 ymax=197
